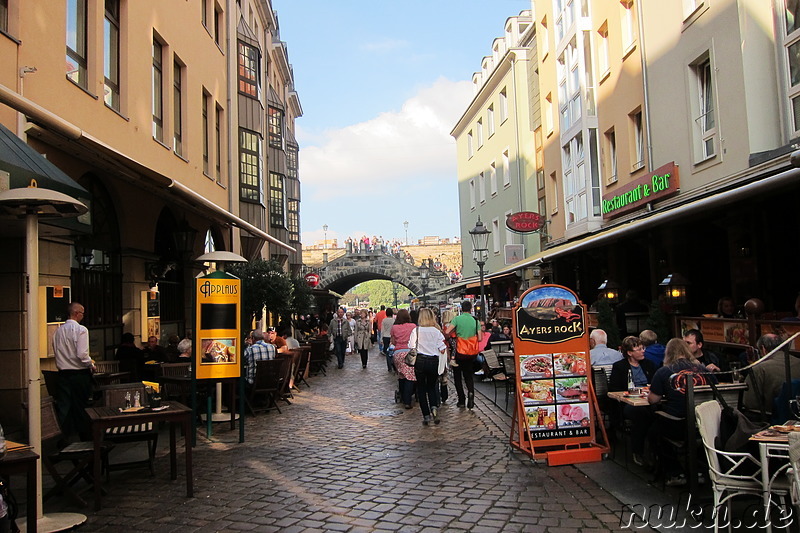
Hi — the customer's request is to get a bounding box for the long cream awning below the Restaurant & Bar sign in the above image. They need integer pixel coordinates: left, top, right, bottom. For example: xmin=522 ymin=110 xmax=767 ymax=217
xmin=494 ymin=162 xmax=800 ymax=276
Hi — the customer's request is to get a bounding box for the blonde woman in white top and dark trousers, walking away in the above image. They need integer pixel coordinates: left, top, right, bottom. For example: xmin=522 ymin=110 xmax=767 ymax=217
xmin=408 ymin=307 xmax=447 ymax=426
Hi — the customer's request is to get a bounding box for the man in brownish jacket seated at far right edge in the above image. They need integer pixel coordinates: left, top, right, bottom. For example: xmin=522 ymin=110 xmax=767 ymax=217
xmin=744 ymin=333 xmax=800 ymax=414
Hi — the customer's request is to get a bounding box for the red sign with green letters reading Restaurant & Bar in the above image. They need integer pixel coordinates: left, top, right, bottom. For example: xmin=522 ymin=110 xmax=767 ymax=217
xmin=603 ymin=161 xmax=680 ymax=218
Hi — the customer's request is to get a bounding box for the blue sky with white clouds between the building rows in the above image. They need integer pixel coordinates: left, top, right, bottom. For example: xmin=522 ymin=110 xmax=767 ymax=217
xmin=272 ymin=0 xmax=531 ymax=245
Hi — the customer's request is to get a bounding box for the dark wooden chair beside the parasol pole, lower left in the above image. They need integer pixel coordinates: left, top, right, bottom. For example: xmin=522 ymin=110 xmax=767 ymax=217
xmin=40 ymin=396 xmax=114 ymax=507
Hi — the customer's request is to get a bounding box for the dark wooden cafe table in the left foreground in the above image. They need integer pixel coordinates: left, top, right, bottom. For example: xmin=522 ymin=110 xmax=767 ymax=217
xmin=86 ymin=402 xmax=194 ymax=511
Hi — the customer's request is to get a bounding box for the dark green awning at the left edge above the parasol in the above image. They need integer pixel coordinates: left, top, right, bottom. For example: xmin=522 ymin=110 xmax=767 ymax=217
xmin=0 ymin=124 xmax=91 ymax=232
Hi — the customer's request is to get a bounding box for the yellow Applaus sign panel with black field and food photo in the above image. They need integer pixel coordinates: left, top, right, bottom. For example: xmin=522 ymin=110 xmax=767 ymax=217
xmin=194 ymin=271 xmax=242 ymax=379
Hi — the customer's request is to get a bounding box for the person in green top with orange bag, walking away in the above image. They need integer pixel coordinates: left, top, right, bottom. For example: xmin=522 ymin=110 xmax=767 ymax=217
xmin=444 ymin=300 xmax=483 ymax=409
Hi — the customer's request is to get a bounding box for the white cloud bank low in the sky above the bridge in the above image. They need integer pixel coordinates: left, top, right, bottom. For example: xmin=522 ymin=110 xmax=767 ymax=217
xmin=298 ymin=78 xmax=472 ymax=204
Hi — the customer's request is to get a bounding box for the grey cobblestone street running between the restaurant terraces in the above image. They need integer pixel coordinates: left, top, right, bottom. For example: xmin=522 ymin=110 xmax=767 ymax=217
xmin=56 ymin=350 xmax=648 ymax=533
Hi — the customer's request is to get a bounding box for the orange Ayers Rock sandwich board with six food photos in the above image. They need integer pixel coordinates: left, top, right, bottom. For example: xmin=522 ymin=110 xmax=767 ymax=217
xmin=511 ymin=285 xmax=608 ymax=465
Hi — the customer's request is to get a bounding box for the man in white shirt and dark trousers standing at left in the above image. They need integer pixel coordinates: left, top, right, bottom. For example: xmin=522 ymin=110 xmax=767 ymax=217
xmin=53 ymin=302 xmax=95 ymax=440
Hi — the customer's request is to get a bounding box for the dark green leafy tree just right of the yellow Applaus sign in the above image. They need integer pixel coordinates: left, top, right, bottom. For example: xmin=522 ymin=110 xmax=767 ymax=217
xmin=228 ymin=259 xmax=294 ymax=319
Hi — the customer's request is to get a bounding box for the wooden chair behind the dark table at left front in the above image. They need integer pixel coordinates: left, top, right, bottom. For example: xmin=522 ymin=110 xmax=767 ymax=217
xmin=103 ymin=383 xmax=158 ymax=476
